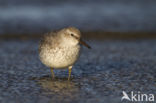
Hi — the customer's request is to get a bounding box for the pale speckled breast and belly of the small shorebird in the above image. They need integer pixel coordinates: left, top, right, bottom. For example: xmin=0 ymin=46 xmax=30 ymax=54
xmin=39 ymin=45 xmax=80 ymax=68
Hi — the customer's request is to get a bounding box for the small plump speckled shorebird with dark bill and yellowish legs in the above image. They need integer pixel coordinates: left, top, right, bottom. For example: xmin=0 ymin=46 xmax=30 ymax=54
xmin=38 ymin=27 xmax=91 ymax=80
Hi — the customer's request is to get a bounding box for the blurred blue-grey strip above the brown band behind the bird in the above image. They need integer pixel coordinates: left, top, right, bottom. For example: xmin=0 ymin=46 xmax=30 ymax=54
xmin=0 ymin=0 xmax=156 ymax=34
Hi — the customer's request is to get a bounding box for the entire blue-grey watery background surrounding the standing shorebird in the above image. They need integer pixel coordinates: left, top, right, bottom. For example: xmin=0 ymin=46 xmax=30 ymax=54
xmin=0 ymin=0 xmax=156 ymax=103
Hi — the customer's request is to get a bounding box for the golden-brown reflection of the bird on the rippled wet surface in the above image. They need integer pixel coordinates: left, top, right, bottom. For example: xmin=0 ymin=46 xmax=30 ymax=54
xmin=35 ymin=76 xmax=79 ymax=96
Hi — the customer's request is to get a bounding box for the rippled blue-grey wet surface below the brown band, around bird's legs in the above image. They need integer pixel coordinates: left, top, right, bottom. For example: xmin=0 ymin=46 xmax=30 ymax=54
xmin=0 ymin=40 xmax=156 ymax=103
